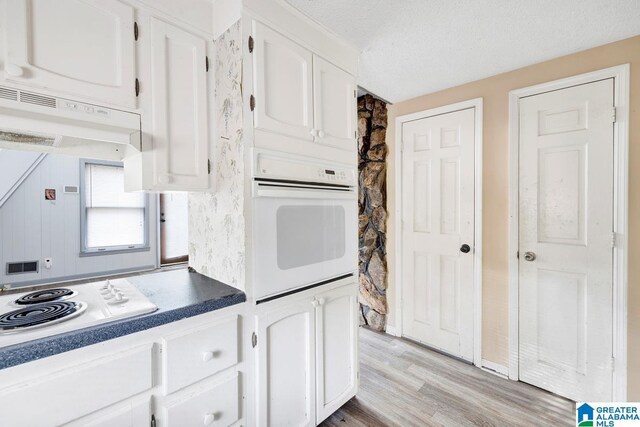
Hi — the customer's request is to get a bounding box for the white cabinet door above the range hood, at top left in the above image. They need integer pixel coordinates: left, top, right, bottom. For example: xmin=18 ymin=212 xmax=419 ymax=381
xmin=3 ymin=0 xmax=136 ymax=107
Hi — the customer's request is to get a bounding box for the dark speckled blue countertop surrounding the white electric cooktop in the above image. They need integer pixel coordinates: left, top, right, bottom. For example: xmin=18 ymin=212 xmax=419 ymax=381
xmin=0 ymin=269 xmax=246 ymax=369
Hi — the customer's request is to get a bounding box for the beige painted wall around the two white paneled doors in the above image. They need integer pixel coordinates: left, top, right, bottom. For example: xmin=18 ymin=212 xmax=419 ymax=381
xmin=387 ymin=36 xmax=640 ymax=401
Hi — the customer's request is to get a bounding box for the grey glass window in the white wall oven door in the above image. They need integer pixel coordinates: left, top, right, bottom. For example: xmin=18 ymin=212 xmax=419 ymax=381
xmin=276 ymin=206 xmax=346 ymax=270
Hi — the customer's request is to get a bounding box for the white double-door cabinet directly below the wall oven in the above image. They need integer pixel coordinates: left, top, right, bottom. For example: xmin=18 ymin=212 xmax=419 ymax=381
xmin=256 ymin=284 xmax=358 ymax=427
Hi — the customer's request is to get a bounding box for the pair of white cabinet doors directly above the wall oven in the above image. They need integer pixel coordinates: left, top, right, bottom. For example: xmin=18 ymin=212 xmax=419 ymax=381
xmin=254 ymin=21 xmax=356 ymax=155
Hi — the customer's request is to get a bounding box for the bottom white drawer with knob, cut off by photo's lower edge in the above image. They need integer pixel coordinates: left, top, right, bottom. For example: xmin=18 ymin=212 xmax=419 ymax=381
xmin=162 ymin=373 xmax=240 ymax=427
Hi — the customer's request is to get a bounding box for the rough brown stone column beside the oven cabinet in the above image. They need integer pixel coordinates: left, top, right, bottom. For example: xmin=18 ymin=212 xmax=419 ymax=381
xmin=358 ymin=95 xmax=388 ymax=331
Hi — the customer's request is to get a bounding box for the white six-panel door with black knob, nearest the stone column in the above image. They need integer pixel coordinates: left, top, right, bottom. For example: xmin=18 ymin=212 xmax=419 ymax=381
xmin=402 ymin=108 xmax=475 ymax=361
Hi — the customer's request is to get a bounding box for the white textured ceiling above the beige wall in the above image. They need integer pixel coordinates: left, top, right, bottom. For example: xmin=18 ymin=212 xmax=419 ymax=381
xmin=287 ymin=0 xmax=640 ymax=102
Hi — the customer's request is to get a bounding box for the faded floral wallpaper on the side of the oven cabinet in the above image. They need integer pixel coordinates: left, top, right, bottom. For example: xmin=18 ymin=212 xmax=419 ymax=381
xmin=189 ymin=21 xmax=245 ymax=289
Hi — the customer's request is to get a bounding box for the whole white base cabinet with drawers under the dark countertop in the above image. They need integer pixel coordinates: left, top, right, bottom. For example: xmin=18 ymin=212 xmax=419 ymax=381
xmin=0 ymin=307 xmax=245 ymax=427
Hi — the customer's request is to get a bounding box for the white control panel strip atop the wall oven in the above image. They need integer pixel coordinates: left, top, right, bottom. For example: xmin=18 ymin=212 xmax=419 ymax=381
xmin=254 ymin=153 xmax=358 ymax=186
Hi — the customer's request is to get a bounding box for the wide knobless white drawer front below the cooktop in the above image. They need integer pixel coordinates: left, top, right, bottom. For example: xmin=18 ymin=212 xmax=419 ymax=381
xmin=0 ymin=344 xmax=153 ymax=427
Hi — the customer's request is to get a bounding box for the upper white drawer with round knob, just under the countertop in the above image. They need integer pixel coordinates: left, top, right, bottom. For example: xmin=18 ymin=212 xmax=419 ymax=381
xmin=163 ymin=316 xmax=238 ymax=394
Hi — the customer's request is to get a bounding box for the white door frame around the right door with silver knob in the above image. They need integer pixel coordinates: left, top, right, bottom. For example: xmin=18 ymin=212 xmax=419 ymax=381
xmin=509 ymin=64 xmax=630 ymax=402
